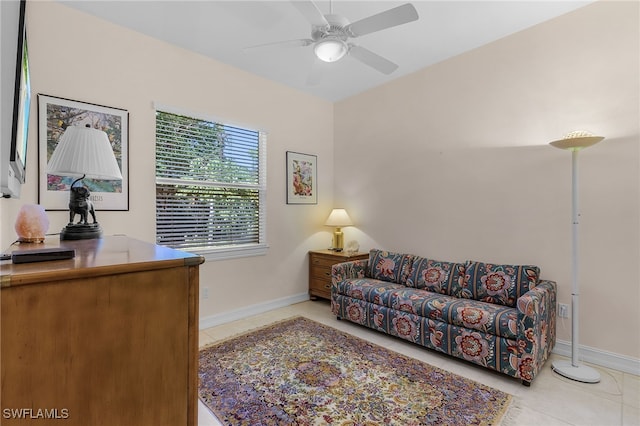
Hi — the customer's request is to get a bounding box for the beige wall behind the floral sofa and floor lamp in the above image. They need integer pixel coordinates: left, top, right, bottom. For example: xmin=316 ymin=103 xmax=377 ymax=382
xmin=334 ymin=2 xmax=640 ymax=359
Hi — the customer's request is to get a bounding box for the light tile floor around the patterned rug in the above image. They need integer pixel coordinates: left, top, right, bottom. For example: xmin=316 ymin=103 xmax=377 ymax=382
xmin=198 ymin=300 xmax=640 ymax=426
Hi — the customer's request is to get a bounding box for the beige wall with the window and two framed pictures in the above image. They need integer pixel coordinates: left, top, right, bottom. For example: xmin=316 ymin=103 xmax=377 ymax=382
xmin=0 ymin=1 xmax=333 ymax=317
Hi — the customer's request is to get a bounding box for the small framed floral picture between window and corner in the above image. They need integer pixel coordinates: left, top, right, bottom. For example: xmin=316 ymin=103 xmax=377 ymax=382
xmin=287 ymin=151 xmax=318 ymax=204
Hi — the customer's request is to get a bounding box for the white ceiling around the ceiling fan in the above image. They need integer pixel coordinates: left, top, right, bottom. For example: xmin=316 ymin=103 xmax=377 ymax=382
xmin=59 ymin=0 xmax=593 ymax=101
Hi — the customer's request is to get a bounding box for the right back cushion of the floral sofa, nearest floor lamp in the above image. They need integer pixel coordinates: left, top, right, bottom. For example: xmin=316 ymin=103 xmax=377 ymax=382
xmin=463 ymin=260 xmax=540 ymax=308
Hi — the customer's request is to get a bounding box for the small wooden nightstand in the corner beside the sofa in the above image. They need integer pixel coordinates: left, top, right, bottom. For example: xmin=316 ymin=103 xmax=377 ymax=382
xmin=309 ymin=250 xmax=369 ymax=300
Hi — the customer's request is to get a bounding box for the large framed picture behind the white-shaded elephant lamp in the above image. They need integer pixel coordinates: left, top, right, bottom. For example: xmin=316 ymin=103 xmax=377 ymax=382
xmin=38 ymin=94 xmax=129 ymax=211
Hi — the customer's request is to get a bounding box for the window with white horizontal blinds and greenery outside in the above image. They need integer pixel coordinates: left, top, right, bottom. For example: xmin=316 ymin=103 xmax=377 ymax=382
xmin=156 ymin=110 xmax=267 ymax=258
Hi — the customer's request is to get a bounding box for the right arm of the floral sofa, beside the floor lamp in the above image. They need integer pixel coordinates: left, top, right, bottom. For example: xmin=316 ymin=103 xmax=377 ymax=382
xmin=517 ymin=280 xmax=556 ymax=382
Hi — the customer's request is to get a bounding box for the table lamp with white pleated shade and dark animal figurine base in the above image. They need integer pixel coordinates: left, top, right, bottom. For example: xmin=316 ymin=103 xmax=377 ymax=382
xmin=47 ymin=125 xmax=122 ymax=240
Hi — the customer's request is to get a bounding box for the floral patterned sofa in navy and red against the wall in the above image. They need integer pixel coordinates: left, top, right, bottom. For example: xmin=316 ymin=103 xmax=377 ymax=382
xmin=331 ymin=249 xmax=556 ymax=386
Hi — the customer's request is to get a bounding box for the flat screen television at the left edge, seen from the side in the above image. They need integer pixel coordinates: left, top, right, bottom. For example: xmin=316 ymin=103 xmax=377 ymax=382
xmin=0 ymin=0 xmax=31 ymax=197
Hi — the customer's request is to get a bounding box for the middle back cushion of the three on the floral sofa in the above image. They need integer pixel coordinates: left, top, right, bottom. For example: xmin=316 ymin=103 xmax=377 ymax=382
xmin=407 ymin=256 xmax=465 ymax=297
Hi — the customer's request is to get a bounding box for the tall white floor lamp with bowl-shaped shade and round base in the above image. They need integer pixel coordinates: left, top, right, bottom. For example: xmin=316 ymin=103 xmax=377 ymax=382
xmin=551 ymin=132 xmax=604 ymax=383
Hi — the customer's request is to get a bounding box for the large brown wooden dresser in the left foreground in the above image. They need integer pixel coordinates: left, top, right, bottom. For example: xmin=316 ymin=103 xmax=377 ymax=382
xmin=0 ymin=236 xmax=204 ymax=426
